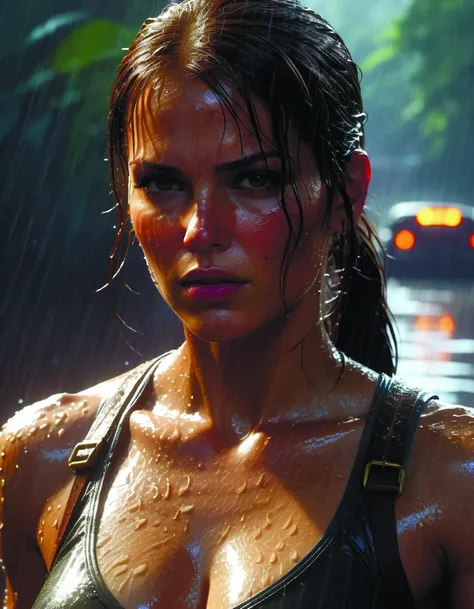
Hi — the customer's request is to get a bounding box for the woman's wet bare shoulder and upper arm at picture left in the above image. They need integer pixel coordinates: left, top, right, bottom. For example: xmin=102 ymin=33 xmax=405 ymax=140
xmin=0 ymin=368 xmax=130 ymax=609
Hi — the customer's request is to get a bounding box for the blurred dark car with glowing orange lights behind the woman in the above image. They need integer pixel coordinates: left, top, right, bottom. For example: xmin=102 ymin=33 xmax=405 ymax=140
xmin=380 ymin=201 xmax=474 ymax=280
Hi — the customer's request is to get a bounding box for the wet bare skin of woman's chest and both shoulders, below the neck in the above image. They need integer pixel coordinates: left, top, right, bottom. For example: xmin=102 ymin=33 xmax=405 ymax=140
xmin=2 ymin=364 xmax=474 ymax=609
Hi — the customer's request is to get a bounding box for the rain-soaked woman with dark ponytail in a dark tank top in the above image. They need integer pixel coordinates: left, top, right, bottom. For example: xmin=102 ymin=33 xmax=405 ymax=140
xmin=2 ymin=0 xmax=474 ymax=609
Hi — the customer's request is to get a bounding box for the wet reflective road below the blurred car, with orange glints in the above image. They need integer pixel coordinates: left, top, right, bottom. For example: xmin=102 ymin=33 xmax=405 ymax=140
xmin=388 ymin=280 xmax=474 ymax=407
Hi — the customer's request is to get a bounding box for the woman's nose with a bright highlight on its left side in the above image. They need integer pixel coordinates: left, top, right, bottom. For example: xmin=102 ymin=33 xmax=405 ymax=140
xmin=183 ymin=197 xmax=232 ymax=253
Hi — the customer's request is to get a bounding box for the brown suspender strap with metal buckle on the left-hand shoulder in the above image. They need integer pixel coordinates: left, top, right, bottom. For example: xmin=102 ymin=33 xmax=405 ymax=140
xmin=51 ymin=352 xmax=170 ymax=568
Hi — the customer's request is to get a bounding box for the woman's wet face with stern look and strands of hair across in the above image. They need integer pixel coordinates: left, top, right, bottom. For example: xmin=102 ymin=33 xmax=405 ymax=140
xmin=128 ymin=79 xmax=328 ymax=341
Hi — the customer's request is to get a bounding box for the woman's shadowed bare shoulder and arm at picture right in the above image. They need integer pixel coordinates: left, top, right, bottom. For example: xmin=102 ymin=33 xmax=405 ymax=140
xmin=410 ymin=400 xmax=474 ymax=609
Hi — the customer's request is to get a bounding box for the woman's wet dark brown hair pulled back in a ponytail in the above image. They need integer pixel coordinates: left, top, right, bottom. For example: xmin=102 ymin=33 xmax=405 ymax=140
xmin=109 ymin=0 xmax=397 ymax=375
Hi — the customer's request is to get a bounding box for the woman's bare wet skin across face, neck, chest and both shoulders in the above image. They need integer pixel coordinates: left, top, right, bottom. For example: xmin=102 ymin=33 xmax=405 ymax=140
xmin=2 ymin=81 xmax=474 ymax=609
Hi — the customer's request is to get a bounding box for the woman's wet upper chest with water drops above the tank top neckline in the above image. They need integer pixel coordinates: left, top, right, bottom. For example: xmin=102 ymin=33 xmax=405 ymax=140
xmin=39 ymin=413 xmax=440 ymax=609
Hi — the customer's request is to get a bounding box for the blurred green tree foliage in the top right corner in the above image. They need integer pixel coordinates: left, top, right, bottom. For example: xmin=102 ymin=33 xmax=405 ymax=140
xmin=365 ymin=0 xmax=474 ymax=204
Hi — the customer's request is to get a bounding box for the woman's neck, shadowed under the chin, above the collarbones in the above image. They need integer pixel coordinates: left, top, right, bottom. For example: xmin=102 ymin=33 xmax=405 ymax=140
xmin=168 ymin=298 xmax=341 ymax=444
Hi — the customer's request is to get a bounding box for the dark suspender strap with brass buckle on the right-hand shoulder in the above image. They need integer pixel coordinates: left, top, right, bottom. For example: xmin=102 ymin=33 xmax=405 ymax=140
xmin=363 ymin=380 xmax=438 ymax=609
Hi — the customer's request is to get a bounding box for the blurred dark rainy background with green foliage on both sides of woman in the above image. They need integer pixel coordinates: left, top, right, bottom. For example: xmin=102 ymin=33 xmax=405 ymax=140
xmin=0 ymin=0 xmax=474 ymax=420
